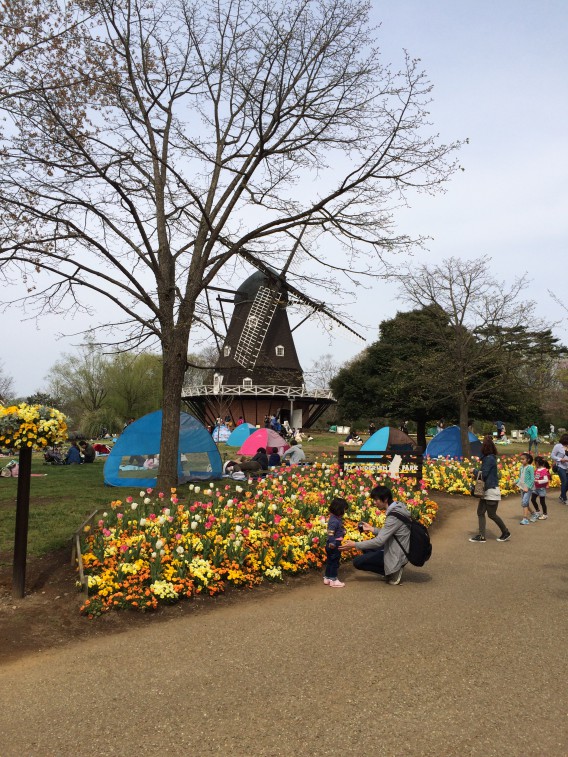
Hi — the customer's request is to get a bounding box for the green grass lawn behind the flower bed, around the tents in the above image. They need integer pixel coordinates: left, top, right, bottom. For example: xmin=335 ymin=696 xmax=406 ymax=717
xmin=0 ymin=432 xmax=552 ymax=563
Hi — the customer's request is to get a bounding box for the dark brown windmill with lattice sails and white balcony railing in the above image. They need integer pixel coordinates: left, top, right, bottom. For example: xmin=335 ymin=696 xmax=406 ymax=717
xmin=184 ymin=245 xmax=362 ymax=428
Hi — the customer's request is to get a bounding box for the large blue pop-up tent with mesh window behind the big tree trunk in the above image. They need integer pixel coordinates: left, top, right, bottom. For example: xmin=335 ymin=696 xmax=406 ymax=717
xmin=104 ymin=410 xmax=223 ymax=488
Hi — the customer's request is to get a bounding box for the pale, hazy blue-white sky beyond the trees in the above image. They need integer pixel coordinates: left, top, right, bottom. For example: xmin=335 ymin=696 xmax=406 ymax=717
xmin=0 ymin=0 xmax=568 ymax=396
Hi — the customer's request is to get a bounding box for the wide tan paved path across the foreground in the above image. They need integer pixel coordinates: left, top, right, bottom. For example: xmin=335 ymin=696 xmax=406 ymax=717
xmin=0 ymin=498 xmax=568 ymax=757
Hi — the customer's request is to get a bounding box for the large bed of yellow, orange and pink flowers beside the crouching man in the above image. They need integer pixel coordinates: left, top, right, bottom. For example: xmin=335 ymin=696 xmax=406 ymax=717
xmin=77 ymin=464 xmax=437 ymax=616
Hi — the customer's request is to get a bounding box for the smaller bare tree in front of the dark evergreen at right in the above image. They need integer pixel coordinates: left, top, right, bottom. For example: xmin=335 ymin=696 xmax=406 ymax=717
xmin=396 ymin=258 xmax=534 ymax=455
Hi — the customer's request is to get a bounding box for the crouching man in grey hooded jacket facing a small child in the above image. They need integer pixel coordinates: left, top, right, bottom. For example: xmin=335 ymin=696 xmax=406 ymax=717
xmin=339 ymin=486 xmax=410 ymax=586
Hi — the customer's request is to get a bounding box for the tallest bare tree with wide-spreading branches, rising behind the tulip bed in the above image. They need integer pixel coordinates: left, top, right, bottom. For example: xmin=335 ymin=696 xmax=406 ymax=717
xmin=0 ymin=0 xmax=457 ymax=487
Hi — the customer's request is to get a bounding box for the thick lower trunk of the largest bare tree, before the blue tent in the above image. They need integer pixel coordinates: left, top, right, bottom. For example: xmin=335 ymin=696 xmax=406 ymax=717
xmin=157 ymin=334 xmax=188 ymax=493
